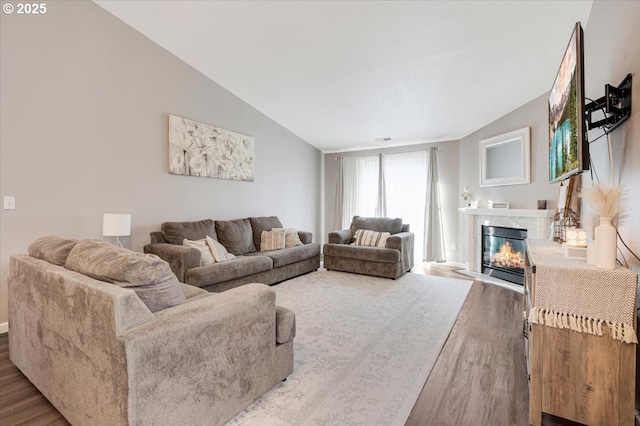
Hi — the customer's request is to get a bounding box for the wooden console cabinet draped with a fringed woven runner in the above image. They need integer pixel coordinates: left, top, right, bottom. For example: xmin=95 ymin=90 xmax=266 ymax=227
xmin=524 ymin=240 xmax=637 ymax=426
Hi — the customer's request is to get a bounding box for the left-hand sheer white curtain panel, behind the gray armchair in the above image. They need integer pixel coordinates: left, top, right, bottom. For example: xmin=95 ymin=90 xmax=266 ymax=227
xmin=337 ymin=157 xmax=380 ymax=225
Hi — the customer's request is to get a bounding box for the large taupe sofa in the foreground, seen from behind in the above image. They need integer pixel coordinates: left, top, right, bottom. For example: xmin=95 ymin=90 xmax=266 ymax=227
xmin=9 ymin=237 xmax=295 ymax=425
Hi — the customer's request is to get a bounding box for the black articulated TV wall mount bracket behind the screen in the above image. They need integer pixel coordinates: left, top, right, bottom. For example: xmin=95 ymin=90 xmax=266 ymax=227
xmin=584 ymin=74 xmax=631 ymax=133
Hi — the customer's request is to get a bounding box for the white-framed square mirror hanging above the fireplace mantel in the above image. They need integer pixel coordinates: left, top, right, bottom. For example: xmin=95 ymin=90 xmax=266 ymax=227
xmin=480 ymin=127 xmax=531 ymax=186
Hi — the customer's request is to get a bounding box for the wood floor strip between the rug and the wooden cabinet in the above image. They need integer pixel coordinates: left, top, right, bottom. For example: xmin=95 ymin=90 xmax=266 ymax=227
xmin=407 ymin=265 xmax=529 ymax=426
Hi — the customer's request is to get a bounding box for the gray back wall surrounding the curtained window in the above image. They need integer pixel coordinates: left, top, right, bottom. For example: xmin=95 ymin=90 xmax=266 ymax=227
xmin=323 ymin=141 xmax=462 ymax=262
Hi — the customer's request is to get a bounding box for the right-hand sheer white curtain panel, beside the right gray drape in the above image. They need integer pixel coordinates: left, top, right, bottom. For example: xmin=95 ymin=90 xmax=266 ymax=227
xmin=384 ymin=151 xmax=429 ymax=262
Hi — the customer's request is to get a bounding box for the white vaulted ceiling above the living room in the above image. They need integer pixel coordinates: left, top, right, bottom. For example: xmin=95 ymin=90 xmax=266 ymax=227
xmin=96 ymin=0 xmax=592 ymax=152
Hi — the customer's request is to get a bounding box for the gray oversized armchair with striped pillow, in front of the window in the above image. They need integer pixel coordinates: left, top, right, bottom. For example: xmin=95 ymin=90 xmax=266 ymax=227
xmin=322 ymin=216 xmax=414 ymax=279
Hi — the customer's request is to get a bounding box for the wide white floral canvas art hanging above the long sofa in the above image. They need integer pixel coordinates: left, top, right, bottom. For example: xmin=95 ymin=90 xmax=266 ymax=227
xmin=169 ymin=115 xmax=255 ymax=182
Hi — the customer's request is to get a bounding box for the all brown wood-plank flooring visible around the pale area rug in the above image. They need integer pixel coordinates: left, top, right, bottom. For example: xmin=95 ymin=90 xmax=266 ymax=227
xmin=0 ymin=265 xmax=592 ymax=426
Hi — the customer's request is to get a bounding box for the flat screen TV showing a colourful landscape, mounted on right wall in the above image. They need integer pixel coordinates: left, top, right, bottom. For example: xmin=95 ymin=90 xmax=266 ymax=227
xmin=549 ymin=22 xmax=589 ymax=182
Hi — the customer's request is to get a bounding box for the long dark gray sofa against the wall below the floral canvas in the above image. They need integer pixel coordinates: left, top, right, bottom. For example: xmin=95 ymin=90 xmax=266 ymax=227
xmin=144 ymin=216 xmax=320 ymax=292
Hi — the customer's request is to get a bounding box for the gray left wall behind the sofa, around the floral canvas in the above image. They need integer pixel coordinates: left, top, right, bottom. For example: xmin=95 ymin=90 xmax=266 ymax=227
xmin=0 ymin=1 xmax=322 ymax=323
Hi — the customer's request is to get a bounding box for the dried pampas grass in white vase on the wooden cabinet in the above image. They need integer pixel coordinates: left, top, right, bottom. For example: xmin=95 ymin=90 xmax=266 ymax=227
xmin=582 ymin=184 xmax=622 ymax=269
